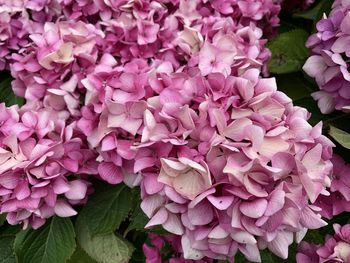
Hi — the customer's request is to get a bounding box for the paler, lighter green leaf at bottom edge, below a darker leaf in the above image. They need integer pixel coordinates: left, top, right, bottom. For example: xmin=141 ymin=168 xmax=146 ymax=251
xmin=76 ymin=217 xmax=134 ymax=263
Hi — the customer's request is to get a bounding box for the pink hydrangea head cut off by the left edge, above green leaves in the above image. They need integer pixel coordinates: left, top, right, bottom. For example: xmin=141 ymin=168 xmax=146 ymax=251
xmin=0 ymin=104 xmax=97 ymax=228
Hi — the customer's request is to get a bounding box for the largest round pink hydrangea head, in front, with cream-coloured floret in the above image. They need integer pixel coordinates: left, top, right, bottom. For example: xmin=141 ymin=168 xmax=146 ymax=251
xmin=137 ymin=69 xmax=333 ymax=262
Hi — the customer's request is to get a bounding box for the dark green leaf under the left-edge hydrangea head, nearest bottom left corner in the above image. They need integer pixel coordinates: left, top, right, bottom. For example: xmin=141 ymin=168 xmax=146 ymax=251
xmin=14 ymin=217 xmax=76 ymax=263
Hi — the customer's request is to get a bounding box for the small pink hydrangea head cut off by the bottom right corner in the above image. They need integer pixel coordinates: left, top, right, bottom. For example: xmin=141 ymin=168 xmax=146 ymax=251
xmin=297 ymin=224 xmax=350 ymax=263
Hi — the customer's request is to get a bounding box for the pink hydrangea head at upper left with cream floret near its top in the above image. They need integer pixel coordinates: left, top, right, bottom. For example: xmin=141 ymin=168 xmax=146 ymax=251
xmin=11 ymin=19 xmax=103 ymax=111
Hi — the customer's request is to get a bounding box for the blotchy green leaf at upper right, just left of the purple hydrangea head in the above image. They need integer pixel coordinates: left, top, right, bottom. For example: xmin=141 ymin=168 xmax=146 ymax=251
xmin=268 ymin=29 xmax=309 ymax=74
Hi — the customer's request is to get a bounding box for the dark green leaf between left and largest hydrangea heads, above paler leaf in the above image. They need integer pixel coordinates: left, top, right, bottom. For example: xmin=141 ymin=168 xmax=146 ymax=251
xmin=79 ymin=184 xmax=133 ymax=236
